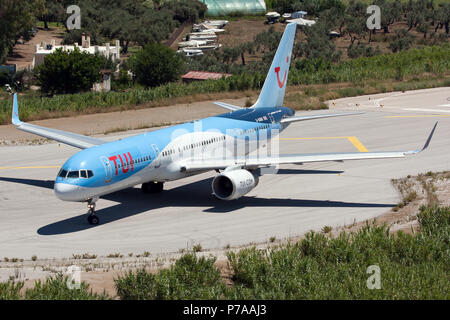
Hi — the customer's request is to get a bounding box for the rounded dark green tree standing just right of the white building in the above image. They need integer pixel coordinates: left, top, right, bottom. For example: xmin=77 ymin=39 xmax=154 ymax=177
xmin=129 ymin=43 xmax=183 ymax=87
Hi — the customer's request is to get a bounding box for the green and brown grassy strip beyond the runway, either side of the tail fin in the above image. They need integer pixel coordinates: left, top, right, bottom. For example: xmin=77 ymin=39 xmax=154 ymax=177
xmin=0 ymin=45 xmax=450 ymax=124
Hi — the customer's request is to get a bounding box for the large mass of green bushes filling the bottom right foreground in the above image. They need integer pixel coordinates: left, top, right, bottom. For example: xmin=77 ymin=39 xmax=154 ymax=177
xmin=228 ymin=207 xmax=450 ymax=299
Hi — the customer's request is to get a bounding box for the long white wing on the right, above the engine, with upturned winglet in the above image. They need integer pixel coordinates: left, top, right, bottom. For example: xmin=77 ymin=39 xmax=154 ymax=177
xmin=181 ymin=122 xmax=437 ymax=172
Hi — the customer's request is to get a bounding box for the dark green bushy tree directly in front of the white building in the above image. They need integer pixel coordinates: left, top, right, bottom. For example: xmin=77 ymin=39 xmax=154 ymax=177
xmin=37 ymin=48 xmax=111 ymax=95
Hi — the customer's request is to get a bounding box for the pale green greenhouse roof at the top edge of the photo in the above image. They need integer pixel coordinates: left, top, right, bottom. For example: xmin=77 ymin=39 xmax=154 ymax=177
xmin=201 ymin=0 xmax=266 ymax=16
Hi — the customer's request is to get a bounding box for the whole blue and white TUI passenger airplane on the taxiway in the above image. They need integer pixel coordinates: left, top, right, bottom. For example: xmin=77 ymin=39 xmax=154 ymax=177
xmin=12 ymin=23 xmax=437 ymax=225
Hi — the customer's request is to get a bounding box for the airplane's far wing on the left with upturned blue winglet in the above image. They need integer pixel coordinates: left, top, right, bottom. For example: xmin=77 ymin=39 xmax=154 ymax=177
xmin=12 ymin=93 xmax=107 ymax=149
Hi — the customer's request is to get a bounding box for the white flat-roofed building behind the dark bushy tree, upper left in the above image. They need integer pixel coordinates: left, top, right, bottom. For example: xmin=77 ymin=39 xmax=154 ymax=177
xmin=32 ymin=33 xmax=120 ymax=68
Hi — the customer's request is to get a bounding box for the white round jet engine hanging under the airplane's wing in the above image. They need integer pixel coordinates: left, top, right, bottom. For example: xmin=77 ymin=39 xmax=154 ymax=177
xmin=212 ymin=169 xmax=259 ymax=200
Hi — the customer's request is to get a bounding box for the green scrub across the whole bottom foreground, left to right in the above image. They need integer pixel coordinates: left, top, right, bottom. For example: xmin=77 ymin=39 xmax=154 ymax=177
xmin=0 ymin=205 xmax=450 ymax=300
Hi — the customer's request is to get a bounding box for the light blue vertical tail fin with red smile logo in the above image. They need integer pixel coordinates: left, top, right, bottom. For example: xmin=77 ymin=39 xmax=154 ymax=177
xmin=252 ymin=23 xmax=297 ymax=108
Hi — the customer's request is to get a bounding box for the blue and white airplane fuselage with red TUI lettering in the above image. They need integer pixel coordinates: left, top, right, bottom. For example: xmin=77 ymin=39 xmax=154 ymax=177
xmin=55 ymin=107 xmax=294 ymax=201
